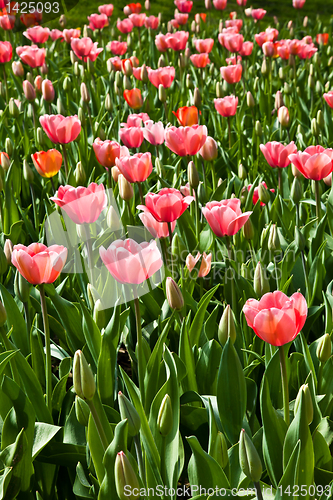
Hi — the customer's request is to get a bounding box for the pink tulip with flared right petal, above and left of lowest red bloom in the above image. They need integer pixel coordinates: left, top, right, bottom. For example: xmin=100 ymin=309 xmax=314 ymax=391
xmin=202 ymin=198 xmax=252 ymax=237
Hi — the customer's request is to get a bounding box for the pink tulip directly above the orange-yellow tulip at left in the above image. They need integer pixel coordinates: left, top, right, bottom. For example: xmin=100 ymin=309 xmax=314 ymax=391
xmin=39 ymin=115 xmax=81 ymax=144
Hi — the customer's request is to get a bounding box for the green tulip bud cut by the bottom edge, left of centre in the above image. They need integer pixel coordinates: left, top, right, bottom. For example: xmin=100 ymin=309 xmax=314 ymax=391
xmin=114 ymin=451 xmax=140 ymax=500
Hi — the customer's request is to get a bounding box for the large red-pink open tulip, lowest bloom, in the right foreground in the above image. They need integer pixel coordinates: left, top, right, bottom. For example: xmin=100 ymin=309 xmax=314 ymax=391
xmin=243 ymin=291 xmax=308 ymax=346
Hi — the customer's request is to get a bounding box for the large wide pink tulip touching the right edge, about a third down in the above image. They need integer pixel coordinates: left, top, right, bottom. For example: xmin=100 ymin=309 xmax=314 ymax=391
xmin=289 ymin=146 xmax=333 ymax=181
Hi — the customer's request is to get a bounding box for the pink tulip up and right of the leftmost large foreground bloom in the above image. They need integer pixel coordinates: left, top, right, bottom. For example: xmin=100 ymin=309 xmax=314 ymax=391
xmin=50 ymin=182 xmax=108 ymax=224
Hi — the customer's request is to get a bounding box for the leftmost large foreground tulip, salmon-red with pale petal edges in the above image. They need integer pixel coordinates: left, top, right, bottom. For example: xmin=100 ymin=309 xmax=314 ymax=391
xmin=12 ymin=243 xmax=67 ymax=285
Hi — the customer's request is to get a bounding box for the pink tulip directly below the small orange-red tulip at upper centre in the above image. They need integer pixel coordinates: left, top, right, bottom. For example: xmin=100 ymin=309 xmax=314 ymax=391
xmin=165 ymin=125 xmax=208 ymax=156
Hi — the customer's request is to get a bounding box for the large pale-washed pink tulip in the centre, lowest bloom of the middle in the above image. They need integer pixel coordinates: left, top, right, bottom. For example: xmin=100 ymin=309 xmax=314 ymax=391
xmin=99 ymin=238 xmax=163 ymax=285
